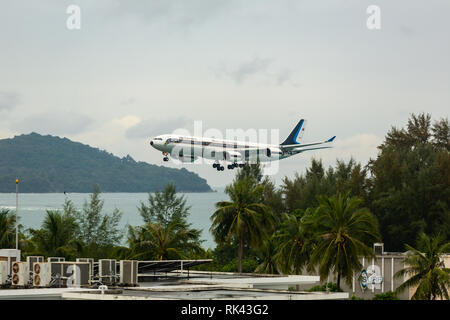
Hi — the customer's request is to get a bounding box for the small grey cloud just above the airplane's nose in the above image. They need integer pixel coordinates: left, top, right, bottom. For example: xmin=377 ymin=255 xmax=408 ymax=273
xmin=125 ymin=117 xmax=189 ymax=138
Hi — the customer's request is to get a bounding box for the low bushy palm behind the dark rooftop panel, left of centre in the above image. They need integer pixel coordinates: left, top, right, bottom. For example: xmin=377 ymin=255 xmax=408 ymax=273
xmin=128 ymin=221 xmax=202 ymax=260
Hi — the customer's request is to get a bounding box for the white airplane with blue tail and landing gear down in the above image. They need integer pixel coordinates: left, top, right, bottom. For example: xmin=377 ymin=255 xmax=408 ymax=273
xmin=150 ymin=119 xmax=336 ymax=171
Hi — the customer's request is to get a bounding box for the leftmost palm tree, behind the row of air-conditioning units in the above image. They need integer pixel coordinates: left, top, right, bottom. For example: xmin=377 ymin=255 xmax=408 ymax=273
xmin=30 ymin=210 xmax=82 ymax=258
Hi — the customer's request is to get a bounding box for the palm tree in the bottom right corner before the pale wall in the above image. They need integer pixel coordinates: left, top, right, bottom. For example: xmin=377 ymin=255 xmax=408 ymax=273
xmin=395 ymin=233 xmax=450 ymax=300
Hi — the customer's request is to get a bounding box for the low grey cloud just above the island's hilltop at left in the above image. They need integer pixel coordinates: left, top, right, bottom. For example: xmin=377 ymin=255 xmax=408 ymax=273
xmin=11 ymin=111 xmax=94 ymax=135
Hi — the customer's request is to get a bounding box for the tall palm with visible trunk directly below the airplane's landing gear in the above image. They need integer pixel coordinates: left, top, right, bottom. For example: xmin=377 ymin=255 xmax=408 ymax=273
xmin=210 ymin=176 xmax=274 ymax=272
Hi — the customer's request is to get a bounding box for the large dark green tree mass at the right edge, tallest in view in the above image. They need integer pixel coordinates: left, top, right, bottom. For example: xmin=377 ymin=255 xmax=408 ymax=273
xmin=369 ymin=113 xmax=450 ymax=251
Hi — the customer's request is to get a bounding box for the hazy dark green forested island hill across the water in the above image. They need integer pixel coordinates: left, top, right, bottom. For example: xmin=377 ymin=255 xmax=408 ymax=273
xmin=0 ymin=133 xmax=212 ymax=193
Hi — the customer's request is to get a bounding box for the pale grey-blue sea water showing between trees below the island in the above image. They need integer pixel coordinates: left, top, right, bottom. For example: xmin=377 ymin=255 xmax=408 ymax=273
xmin=0 ymin=189 xmax=228 ymax=248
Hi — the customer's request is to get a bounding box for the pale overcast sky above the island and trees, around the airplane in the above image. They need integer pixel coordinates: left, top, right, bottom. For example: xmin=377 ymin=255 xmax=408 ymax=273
xmin=0 ymin=0 xmax=450 ymax=187
